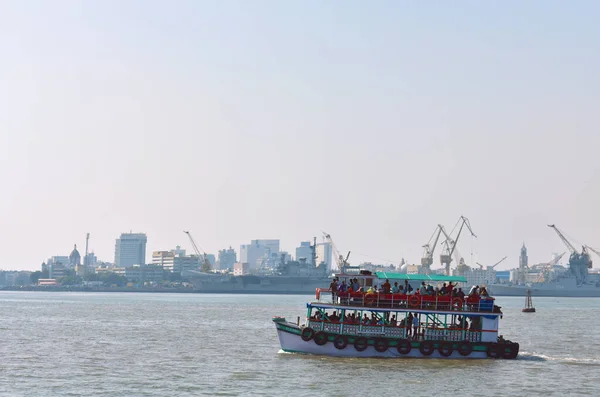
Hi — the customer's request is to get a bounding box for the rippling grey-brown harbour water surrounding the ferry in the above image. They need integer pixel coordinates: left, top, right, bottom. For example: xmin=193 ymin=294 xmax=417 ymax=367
xmin=0 ymin=292 xmax=600 ymax=397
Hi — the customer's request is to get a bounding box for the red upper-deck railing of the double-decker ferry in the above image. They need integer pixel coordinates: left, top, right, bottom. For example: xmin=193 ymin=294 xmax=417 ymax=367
xmin=316 ymin=288 xmax=499 ymax=312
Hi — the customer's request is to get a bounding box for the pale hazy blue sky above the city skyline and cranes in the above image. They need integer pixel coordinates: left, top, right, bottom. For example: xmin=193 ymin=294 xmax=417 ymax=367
xmin=0 ymin=0 xmax=600 ymax=270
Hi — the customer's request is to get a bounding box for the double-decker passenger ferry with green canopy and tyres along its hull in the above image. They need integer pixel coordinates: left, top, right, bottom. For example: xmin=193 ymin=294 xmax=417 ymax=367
xmin=273 ymin=271 xmax=519 ymax=359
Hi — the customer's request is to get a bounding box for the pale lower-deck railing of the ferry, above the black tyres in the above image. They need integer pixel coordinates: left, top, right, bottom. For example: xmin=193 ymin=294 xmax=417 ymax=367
xmin=307 ymin=319 xmax=486 ymax=342
